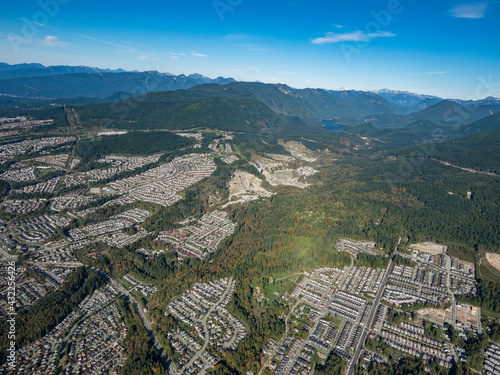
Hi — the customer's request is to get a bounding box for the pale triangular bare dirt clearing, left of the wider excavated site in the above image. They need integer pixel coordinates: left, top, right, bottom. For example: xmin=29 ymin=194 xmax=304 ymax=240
xmin=224 ymin=171 xmax=274 ymax=207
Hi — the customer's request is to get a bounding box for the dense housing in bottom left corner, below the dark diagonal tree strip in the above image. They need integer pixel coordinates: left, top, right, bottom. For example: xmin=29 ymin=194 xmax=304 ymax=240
xmin=0 ymin=285 xmax=127 ymax=374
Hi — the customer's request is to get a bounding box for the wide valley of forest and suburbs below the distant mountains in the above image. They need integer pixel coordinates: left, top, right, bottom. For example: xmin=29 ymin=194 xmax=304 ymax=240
xmin=0 ymin=64 xmax=500 ymax=375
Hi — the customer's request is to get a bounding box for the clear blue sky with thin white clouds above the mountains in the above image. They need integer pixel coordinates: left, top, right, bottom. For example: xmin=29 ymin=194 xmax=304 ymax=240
xmin=0 ymin=0 xmax=500 ymax=99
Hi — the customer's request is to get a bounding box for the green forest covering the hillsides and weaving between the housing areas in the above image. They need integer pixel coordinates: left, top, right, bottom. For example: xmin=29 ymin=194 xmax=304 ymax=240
xmin=0 ymin=74 xmax=500 ymax=375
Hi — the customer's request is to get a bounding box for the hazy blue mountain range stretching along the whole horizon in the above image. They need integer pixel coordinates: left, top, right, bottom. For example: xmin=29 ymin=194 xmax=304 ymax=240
xmin=0 ymin=64 xmax=500 ymax=147
